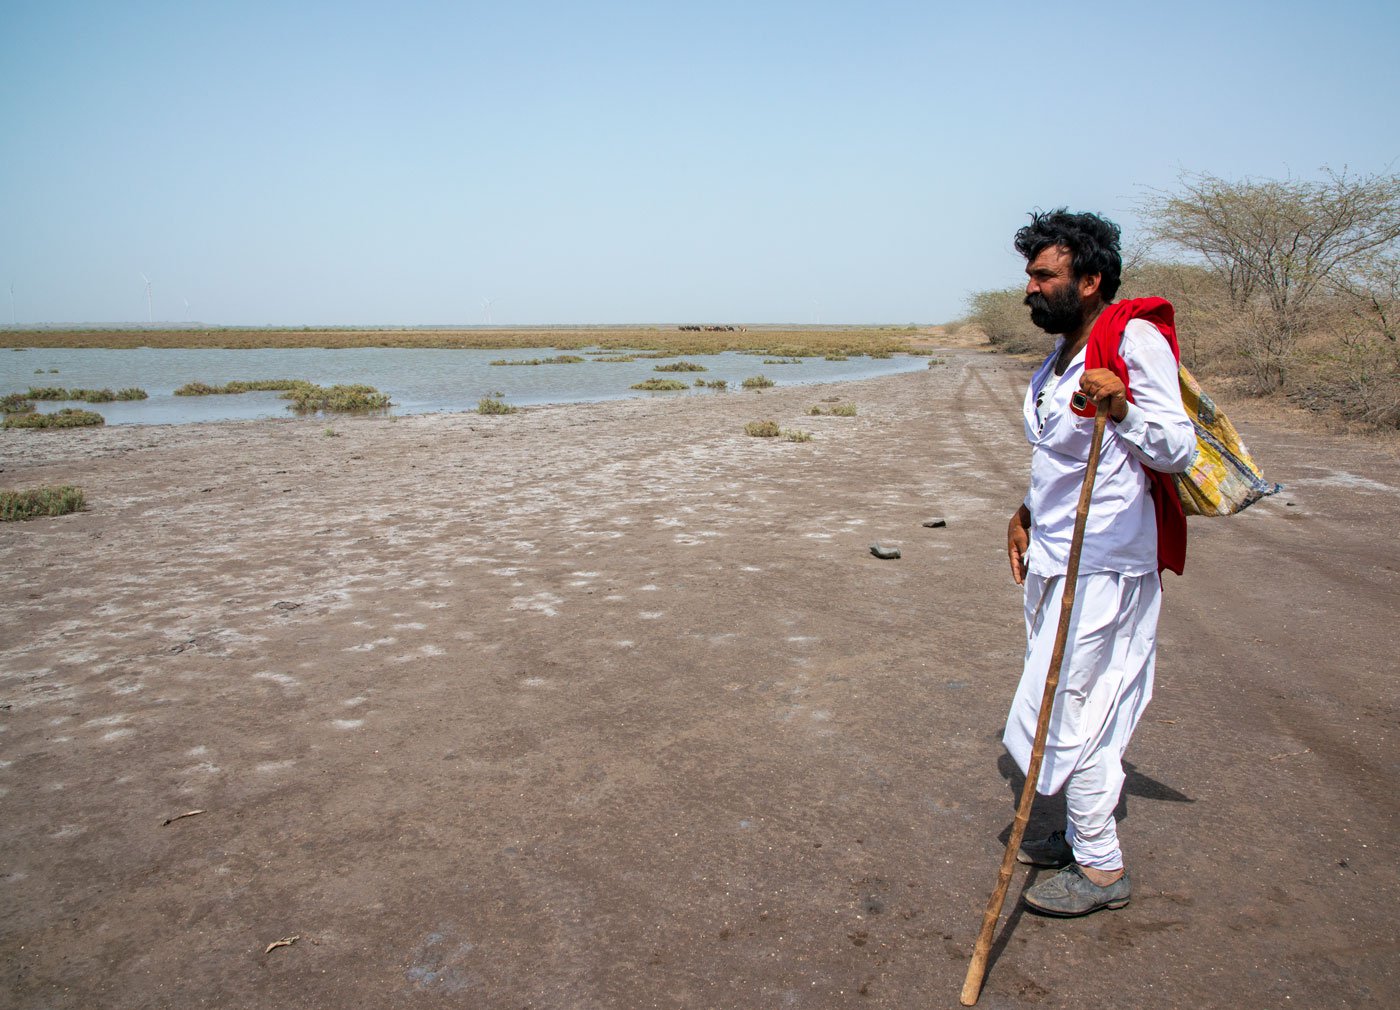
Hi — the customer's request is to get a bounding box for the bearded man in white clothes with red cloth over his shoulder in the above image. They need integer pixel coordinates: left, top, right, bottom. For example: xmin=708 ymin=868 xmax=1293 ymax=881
xmin=1002 ymin=209 xmax=1196 ymax=916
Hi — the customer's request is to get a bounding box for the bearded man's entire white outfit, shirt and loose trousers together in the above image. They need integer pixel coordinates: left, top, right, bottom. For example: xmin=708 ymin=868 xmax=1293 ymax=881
xmin=1002 ymin=319 xmax=1196 ymax=870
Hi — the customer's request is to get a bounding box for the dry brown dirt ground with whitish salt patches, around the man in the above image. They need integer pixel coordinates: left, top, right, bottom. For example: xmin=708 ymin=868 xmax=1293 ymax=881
xmin=0 ymin=349 xmax=1400 ymax=1010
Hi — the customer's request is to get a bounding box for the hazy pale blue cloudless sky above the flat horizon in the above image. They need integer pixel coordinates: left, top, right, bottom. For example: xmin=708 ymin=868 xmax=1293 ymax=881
xmin=0 ymin=0 xmax=1400 ymax=325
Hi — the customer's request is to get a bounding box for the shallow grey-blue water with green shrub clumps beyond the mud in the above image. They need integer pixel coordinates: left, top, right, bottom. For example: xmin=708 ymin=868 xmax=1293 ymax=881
xmin=0 ymin=347 xmax=928 ymax=424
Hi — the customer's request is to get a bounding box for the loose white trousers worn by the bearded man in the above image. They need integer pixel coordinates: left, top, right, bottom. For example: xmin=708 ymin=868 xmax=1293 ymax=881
xmin=1002 ymin=572 xmax=1162 ymax=870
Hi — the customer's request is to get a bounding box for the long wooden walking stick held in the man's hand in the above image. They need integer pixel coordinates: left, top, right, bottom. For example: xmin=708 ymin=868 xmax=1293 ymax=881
xmin=959 ymin=394 xmax=1109 ymax=1006
